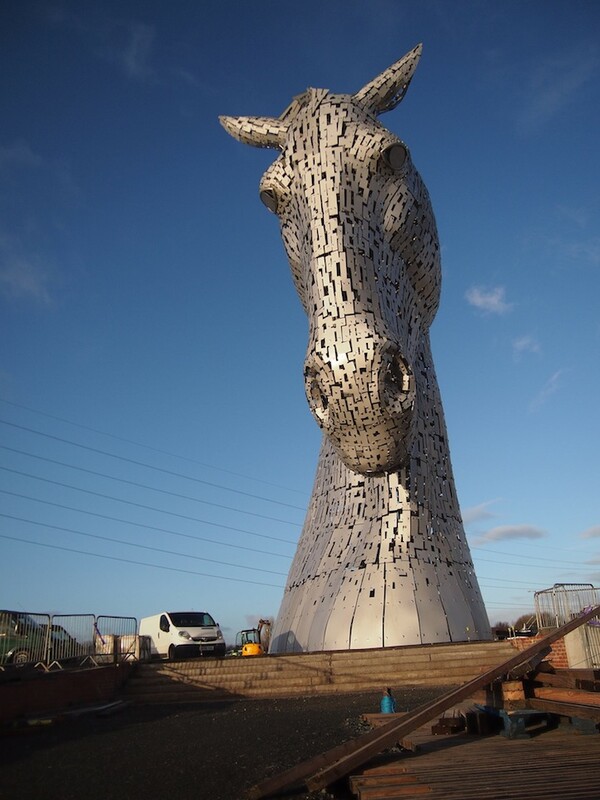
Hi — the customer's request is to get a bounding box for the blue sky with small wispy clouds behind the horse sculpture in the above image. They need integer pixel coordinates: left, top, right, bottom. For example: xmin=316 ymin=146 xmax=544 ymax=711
xmin=0 ymin=0 xmax=600 ymax=641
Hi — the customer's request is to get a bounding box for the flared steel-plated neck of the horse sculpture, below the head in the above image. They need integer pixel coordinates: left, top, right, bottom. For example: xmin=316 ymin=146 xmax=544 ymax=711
xmin=271 ymin=334 xmax=489 ymax=652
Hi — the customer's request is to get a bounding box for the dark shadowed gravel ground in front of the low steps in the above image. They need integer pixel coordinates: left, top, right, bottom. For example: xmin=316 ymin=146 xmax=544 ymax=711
xmin=0 ymin=688 xmax=444 ymax=800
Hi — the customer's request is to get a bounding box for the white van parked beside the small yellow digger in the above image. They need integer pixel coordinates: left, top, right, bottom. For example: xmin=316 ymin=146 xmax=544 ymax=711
xmin=140 ymin=611 xmax=225 ymax=661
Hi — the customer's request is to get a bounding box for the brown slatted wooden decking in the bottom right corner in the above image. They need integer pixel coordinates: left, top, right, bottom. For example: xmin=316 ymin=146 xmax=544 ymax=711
xmin=350 ymin=725 xmax=600 ymax=800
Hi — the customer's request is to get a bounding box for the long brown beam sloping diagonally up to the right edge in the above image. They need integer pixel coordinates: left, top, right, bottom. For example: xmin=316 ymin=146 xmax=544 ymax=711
xmin=248 ymin=606 xmax=600 ymax=800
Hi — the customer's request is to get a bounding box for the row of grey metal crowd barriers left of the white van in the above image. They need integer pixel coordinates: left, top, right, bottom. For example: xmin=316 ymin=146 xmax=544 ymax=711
xmin=0 ymin=610 xmax=145 ymax=670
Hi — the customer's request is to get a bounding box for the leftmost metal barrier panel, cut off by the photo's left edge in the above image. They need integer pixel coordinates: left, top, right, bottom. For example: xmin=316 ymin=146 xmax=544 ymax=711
xmin=0 ymin=610 xmax=50 ymax=669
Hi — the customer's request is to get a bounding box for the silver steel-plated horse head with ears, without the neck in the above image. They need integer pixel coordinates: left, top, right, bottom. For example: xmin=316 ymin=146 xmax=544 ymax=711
xmin=220 ymin=45 xmax=440 ymax=475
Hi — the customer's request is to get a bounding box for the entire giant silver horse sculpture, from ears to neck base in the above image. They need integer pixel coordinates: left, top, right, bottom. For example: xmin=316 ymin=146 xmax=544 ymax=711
xmin=220 ymin=45 xmax=490 ymax=652
